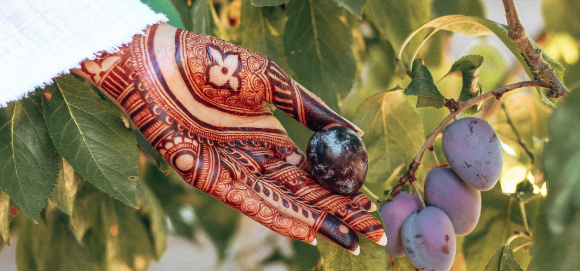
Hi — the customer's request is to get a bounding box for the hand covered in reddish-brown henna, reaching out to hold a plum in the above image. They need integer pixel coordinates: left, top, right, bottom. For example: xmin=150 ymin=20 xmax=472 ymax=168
xmin=74 ymin=24 xmax=387 ymax=254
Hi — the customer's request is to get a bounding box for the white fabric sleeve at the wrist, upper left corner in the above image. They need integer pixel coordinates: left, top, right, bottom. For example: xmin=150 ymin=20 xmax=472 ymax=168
xmin=0 ymin=0 xmax=167 ymax=107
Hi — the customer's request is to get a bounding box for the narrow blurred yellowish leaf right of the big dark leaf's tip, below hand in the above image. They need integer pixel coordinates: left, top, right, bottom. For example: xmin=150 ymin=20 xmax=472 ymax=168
xmin=137 ymin=182 xmax=167 ymax=261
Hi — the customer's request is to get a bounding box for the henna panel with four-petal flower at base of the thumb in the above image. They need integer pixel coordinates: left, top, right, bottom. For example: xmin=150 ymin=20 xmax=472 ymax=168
xmin=175 ymin=30 xmax=272 ymax=116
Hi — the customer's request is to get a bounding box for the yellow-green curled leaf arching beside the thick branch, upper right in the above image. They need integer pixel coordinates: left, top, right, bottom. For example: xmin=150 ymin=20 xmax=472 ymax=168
xmin=398 ymin=15 xmax=564 ymax=106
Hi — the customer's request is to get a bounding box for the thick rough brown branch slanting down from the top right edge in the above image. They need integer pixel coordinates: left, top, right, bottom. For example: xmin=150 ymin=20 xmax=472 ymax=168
xmin=502 ymin=0 xmax=568 ymax=99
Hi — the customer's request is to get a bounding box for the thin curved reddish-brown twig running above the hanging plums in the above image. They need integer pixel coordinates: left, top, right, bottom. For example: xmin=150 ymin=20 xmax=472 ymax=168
xmin=391 ymin=79 xmax=550 ymax=196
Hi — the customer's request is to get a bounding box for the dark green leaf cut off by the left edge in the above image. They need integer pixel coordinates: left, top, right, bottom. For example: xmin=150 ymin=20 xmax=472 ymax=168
xmin=0 ymin=94 xmax=60 ymax=221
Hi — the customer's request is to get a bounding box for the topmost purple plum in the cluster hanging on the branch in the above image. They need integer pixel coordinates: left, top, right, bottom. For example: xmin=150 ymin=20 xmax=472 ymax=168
xmin=443 ymin=118 xmax=503 ymax=191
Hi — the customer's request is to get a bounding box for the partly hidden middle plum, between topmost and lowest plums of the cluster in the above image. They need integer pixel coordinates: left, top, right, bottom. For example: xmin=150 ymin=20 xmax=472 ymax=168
xmin=425 ymin=168 xmax=481 ymax=236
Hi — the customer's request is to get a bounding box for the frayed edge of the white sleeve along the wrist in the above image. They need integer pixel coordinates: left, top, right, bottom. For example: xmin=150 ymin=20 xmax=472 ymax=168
xmin=0 ymin=14 xmax=169 ymax=108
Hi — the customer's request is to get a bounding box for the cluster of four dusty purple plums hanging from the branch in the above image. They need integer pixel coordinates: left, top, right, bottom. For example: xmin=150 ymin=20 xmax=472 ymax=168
xmin=379 ymin=118 xmax=503 ymax=271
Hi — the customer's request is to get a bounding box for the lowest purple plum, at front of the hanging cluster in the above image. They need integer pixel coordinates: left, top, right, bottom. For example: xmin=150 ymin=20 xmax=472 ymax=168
xmin=401 ymin=206 xmax=455 ymax=271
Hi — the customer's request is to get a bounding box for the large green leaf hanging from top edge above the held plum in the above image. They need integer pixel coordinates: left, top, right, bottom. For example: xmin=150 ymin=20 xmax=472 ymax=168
xmin=284 ymin=0 xmax=356 ymax=110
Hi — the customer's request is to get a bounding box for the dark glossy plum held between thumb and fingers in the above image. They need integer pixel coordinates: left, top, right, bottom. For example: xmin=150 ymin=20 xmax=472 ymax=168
xmin=306 ymin=126 xmax=368 ymax=195
